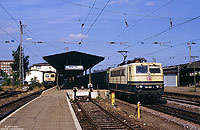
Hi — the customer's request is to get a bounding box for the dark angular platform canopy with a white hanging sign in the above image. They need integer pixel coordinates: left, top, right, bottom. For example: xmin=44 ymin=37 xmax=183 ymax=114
xmin=43 ymin=51 xmax=104 ymax=76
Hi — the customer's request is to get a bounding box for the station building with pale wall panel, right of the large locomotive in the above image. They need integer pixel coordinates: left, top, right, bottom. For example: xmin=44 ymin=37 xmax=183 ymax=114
xmin=163 ymin=61 xmax=200 ymax=87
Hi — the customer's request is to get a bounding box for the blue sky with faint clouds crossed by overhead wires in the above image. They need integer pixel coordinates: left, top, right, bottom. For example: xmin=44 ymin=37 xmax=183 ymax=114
xmin=0 ymin=0 xmax=200 ymax=69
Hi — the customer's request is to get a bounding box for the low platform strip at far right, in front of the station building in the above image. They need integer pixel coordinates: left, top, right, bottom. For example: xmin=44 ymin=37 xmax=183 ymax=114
xmin=164 ymin=87 xmax=200 ymax=96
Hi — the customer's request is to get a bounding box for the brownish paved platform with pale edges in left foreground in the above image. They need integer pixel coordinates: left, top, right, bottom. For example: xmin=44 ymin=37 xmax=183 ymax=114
xmin=0 ymin=88 xmax=81 ymax=130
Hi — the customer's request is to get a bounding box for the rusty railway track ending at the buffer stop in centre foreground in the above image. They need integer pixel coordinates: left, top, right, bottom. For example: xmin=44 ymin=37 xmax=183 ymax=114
xmin=72 ymin=100 xmax=142 ymax=130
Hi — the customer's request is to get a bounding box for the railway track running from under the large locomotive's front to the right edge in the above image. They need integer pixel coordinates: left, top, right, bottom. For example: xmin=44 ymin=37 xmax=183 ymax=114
xmin=145 ymin=105 xmax=200 ymax=124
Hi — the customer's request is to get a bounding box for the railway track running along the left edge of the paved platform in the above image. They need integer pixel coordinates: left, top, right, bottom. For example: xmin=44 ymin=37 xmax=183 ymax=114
xmin=0 ymin=90 xmax=44 ymax=120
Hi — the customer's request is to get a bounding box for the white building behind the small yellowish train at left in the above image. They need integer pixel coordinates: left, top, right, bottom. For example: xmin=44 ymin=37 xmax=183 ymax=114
xmin=25 ymin=63 xmax=56 ymax=83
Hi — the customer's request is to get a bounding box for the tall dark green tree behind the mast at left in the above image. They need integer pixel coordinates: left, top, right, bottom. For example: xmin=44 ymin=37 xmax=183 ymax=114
xmin=11 ymin=46 xmax=29 ymax=85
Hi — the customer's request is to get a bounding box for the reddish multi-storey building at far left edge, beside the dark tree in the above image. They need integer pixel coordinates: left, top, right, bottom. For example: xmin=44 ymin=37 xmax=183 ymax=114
xmin=0 ymin=60 xmax=14 ymax=77
